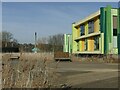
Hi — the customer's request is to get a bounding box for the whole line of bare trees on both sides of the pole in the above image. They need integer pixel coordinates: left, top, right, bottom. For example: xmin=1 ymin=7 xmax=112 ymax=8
xmin=0 ymin=31 xmax=64 ymax=52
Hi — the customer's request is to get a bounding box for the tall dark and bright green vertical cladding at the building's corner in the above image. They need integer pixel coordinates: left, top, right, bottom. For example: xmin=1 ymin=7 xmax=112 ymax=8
xmin=100 ymin=5 xmax=112 ymax=54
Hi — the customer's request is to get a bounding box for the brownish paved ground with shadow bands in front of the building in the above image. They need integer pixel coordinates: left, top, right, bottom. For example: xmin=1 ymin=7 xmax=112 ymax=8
xmin=47 ymin=62 xmax=118 ymax=88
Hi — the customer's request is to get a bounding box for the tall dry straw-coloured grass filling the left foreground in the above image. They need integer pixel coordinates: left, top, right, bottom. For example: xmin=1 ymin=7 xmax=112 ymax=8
xmin=2 ymin=53 xmax=59 ymax=88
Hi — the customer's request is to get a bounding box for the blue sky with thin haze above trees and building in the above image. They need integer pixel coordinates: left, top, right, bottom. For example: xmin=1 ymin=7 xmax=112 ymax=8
xmin=2 ymin=2 xmax=118 ymax=43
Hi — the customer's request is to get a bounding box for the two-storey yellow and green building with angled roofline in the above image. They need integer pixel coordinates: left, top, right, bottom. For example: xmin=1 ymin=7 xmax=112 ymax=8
xmin=71 ymin=5 xmax=120 ymax=54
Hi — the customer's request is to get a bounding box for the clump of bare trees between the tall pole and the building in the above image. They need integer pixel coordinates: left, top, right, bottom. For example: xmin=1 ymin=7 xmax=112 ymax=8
xmin=38 ymin=34 xmax=64 ymax=51
